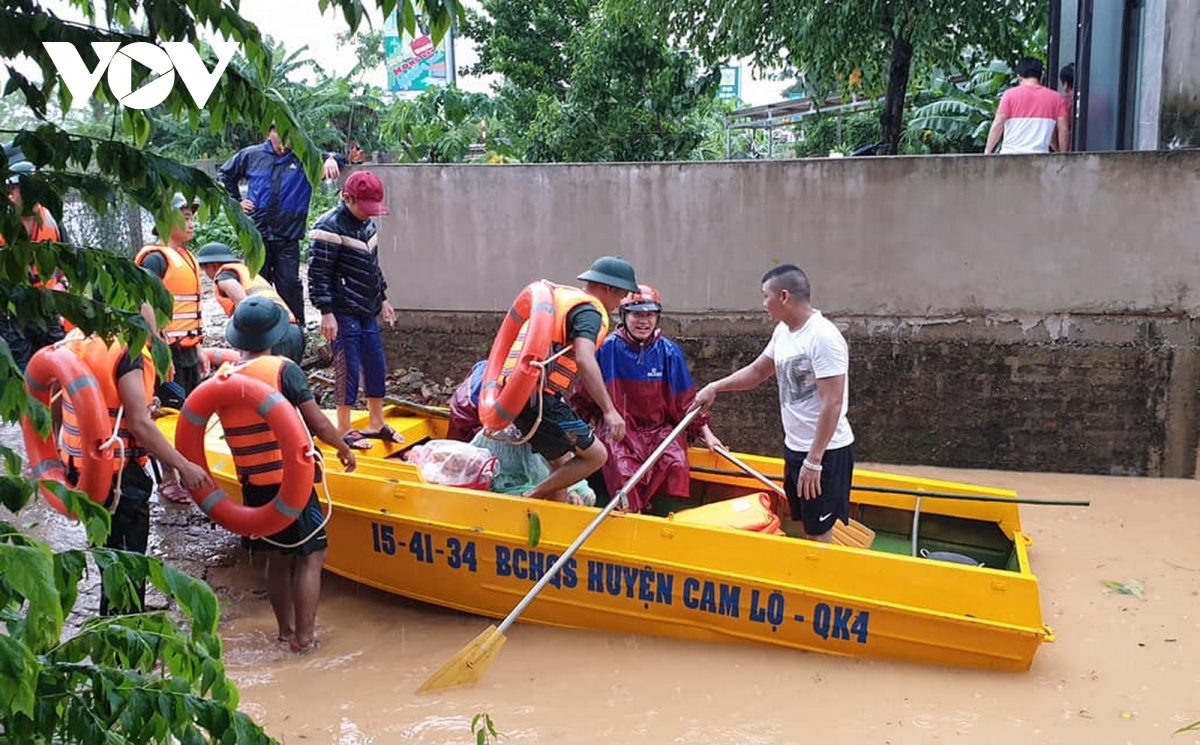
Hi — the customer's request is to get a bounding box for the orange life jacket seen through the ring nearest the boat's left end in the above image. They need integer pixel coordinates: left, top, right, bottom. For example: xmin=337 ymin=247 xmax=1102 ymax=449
xmin=221 ymin=355 xmax=292 ymax=486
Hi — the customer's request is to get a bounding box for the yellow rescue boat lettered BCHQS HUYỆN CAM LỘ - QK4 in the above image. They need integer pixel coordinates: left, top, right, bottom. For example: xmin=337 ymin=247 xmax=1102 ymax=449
xmin=158 ymin=408 xmax=1054 ymax=671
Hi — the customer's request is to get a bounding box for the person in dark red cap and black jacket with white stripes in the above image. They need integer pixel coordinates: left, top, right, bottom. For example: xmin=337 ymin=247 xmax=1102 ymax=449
xmin=308 ymin=170 xmax=403 ymax=450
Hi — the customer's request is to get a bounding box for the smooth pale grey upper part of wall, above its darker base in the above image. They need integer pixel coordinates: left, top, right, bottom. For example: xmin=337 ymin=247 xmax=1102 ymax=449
xmin=376 ymin=152 xmax=1200 ymax=314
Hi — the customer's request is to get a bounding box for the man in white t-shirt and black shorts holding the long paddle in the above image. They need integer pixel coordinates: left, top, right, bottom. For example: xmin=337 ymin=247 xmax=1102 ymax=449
xmin=696 ymin=264 xmax=854 ymax=543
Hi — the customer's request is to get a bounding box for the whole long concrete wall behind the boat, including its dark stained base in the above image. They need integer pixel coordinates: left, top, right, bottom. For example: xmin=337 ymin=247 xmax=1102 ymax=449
xmin=360 ymin=152 xmax=1200 ymax=476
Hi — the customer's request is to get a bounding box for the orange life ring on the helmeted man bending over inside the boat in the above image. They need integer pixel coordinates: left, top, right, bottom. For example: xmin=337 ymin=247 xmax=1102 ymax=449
xmin=479 ymin=281 xmax=554 ymax=432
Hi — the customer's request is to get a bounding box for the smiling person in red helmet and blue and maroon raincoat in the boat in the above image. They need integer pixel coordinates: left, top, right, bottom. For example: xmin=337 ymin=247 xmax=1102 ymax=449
xmin=574 ymin=284 xmax=720 ymax=512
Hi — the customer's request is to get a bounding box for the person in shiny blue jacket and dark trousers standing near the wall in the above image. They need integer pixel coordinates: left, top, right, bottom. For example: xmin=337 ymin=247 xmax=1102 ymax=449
xmin=218 ymin=124 xmax=346 ymax=328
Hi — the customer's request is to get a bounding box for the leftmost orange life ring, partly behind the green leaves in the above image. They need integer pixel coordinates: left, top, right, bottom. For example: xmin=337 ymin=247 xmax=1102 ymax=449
xmin=20 ymin=344 xmax=113 ymax=518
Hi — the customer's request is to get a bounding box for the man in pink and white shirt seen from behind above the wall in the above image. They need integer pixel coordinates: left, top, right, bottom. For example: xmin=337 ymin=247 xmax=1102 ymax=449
xmin=983 ymin=56 xmax=1069 ymax=155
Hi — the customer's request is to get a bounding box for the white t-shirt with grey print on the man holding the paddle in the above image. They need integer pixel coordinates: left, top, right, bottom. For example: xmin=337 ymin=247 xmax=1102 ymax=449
xmin=763 ymin=311 xmax=854 ymax=452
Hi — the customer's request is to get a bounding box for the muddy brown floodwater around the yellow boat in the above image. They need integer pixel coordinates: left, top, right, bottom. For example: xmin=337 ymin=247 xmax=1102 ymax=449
xmin=2 ymin=415 xmax=1200 ymax=745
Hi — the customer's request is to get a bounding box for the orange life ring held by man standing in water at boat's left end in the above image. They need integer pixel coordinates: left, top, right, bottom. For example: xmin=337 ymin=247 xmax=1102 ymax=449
xmin=175 ymin=371 xmax=313 ymax=536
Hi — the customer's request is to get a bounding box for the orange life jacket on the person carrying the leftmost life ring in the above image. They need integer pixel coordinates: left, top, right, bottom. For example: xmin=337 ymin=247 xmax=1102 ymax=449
xmin=59 ymin=336 xmax=155 ymax=473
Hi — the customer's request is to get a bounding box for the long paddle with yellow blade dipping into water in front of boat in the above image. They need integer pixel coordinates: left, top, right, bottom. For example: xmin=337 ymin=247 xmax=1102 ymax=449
xmin=416 ymin=407 xmax=701 ymax=693
